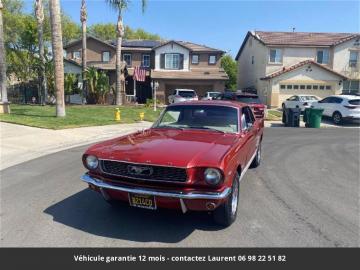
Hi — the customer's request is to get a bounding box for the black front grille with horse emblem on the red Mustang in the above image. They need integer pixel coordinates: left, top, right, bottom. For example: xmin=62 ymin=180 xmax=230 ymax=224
xmin=100 ymin=160 xmax=187 ymax=182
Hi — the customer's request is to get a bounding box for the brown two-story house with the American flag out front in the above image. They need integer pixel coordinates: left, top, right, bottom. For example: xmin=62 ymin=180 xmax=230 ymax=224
xmin=64 ymin=36 xmax=228 ymax=103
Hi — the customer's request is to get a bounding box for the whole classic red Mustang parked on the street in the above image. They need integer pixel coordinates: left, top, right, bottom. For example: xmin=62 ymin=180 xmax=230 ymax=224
xmin=82 ymin=101 xmax=263 ymax=226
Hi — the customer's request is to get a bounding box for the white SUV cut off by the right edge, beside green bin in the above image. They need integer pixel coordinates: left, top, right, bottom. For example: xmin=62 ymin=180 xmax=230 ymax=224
xmin=312 ymin=95 xmax=360 ymax=124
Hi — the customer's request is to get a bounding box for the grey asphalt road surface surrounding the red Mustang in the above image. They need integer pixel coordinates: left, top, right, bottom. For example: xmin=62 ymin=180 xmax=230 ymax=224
xmin=0 ymin=128 xmax=360 ymax=247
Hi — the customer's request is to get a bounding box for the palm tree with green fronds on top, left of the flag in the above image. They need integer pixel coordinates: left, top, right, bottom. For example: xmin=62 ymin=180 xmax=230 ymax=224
xmin=106 ymin=0 xmax=147 ymax=105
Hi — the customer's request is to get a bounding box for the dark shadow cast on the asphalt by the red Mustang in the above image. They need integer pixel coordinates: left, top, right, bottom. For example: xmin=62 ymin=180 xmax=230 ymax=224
xmin=44 ymin=189 xmax=221 ymax=243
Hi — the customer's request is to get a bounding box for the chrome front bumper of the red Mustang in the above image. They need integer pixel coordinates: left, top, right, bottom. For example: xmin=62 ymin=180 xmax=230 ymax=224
xmin=81 ymin=173 xmax=231 ymax=200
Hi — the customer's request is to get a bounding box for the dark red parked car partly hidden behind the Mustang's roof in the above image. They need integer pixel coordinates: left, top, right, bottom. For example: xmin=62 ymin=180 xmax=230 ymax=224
xmin=217 ymin=91 xmax=266 ymax=118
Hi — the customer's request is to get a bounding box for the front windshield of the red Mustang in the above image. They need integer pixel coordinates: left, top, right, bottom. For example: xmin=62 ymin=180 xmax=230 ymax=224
xmin=153 ymin=105 xmax=238 ymax=133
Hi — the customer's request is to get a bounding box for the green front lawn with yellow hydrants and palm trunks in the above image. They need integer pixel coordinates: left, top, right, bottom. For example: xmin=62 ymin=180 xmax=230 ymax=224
xmin=0 ymin=104 xmax=161 ymax=129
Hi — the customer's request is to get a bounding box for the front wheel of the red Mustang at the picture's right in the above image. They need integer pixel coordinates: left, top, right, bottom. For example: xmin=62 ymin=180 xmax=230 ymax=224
xmin=213 ymin=173 xmax=240 ymax=227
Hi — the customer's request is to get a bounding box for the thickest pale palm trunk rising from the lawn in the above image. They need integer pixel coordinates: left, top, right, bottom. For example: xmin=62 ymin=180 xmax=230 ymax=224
xmin=50 ymin=0 xmax=65 ymax=117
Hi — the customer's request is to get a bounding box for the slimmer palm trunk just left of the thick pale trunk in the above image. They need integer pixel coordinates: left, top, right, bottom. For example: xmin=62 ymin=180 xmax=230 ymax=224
xmin=35 ymin=0 xmax=47 ymax=105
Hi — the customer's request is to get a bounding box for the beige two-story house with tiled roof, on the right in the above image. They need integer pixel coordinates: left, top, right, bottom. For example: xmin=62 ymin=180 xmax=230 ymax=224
xmin=235 ymin=31 xmax=360 ymax=107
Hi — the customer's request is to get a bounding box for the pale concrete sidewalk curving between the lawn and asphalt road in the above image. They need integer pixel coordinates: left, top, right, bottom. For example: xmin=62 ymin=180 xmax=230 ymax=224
xmin=0 ymin=122 xmax=151 ymax=170
